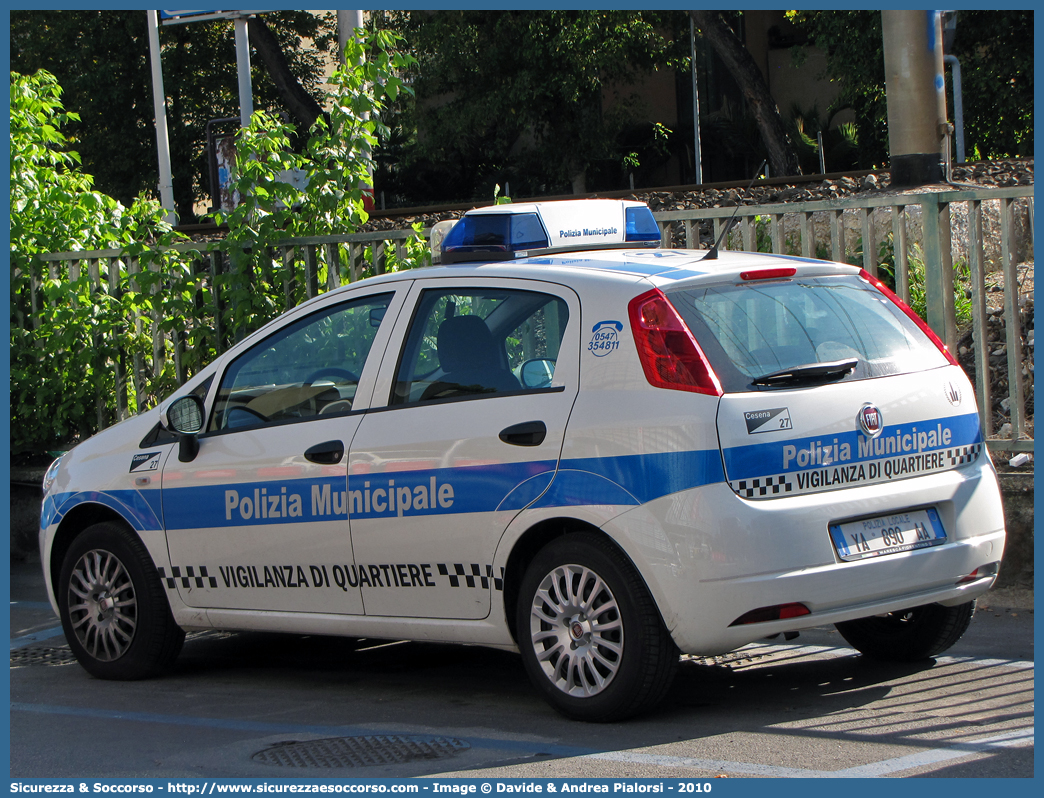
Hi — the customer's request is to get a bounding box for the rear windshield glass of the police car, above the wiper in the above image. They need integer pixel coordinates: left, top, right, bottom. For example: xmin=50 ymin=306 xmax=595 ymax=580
xmin=667 ymin=275 xmax=947 ymax=392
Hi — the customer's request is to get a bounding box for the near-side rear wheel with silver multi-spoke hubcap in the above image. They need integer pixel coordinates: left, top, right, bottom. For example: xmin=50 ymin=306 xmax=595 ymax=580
xmin=516 ymin=533 xmax=679 ymax=722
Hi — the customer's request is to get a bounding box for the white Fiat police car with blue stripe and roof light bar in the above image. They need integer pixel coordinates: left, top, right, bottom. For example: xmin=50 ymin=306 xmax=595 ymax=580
xmin=40 ymin=201 xmax=1004 ymax=721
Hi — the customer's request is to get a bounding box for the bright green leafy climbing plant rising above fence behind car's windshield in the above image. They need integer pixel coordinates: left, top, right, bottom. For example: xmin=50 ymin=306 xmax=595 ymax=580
xmin=213 ymin=31 xmax=417 ymax=335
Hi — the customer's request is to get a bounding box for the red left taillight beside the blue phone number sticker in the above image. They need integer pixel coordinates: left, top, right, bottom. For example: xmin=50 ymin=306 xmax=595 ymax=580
xmin=627 ymin=288 xmax=721 ymax=396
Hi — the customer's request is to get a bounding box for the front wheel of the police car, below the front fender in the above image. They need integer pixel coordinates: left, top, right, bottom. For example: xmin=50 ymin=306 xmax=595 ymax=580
xmin=56 ymin=522 xmax=185 ymax=680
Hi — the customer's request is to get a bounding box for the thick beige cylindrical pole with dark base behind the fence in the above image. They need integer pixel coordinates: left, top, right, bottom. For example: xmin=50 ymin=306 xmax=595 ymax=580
xmin=881 ymin=10 xmax=949 ymax=188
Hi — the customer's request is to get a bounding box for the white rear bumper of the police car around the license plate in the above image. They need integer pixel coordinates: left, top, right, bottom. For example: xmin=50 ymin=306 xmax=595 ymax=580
xmin=607 ymin=460 xmax=1004 ymax=655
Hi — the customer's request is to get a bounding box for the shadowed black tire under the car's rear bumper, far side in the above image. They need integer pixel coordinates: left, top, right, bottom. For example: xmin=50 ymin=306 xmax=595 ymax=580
xmin=836 ymin=601 xmax=975 ymax=662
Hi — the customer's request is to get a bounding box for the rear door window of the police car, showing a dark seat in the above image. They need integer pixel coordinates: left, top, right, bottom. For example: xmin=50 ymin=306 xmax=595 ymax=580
xmin=392 ymin=288 xmax=569 ymax=404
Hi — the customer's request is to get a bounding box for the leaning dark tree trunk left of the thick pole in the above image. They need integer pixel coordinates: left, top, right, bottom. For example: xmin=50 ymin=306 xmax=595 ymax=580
xmin=689 ymin=11 xmax=801 ymax=178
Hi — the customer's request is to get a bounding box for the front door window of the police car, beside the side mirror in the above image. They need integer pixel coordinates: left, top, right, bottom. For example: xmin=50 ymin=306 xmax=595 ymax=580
xmin=210 ymin=294 xmax=393 ymax=430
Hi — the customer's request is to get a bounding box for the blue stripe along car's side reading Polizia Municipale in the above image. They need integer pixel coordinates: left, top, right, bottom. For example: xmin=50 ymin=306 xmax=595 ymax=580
xmin=45 ymin=450 xmax=725 ymax=532
